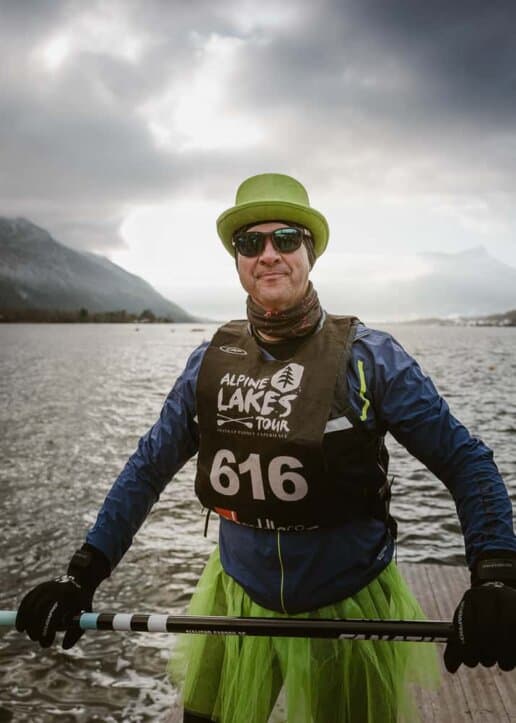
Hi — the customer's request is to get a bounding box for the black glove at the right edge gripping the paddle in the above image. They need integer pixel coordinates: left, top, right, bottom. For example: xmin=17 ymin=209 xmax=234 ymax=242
xmin=444 ymin=550 xmax=516 ymax=673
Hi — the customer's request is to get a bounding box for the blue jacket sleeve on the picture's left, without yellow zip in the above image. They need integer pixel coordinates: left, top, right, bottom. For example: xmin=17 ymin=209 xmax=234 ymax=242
xmin=86 ymin=343 xmax=207 ymax=568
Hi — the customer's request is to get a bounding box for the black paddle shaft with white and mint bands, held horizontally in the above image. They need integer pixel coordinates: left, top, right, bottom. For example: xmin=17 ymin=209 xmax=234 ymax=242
xmin=0 ymin=610 xmax=454 ymax=643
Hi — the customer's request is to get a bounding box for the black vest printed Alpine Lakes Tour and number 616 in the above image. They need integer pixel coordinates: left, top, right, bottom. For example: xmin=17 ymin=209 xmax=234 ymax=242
xmin=195 ymin=315 xmax=390 ymax=530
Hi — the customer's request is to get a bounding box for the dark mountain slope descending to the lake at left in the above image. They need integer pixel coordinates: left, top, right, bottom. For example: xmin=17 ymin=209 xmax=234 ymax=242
xmin=0 ymin=217 xmax=196 ymax=321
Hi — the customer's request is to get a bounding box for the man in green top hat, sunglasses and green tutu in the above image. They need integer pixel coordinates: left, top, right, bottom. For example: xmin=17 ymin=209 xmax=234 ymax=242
xmin=17 ymin=174 xmax=516 ymax=723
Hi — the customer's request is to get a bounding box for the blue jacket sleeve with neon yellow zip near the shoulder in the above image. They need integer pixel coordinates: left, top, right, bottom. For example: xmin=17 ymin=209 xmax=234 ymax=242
xmin=348 ymin=330 xmax=516 ymax=568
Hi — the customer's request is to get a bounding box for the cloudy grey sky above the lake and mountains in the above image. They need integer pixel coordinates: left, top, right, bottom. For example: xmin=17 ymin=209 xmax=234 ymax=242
xmin=0 ymin=0 xmax=516 ymax=318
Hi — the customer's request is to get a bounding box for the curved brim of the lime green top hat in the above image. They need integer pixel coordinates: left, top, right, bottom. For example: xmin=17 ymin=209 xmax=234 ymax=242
xmin=217 ymin=201 xmax=330 ymax=256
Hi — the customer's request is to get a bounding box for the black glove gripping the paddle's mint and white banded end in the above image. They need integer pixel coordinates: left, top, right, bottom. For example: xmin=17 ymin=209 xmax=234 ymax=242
xmin=16 ymin=543 xmax=111 ymax=650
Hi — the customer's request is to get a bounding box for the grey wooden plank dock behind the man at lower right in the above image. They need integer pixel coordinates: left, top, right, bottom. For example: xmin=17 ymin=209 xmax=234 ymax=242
xmin=167 ymin=563 xmax=516 ymax=723
